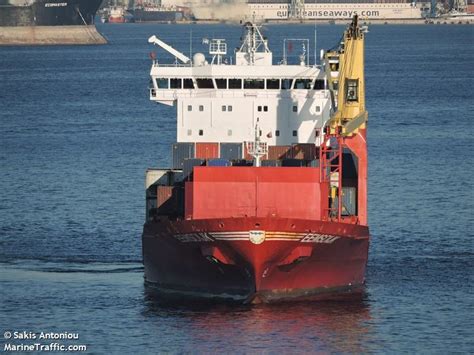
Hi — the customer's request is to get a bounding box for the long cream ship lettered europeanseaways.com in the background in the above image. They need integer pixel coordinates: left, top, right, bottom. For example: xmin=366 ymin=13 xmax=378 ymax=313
xmin=162 ymin=0 xmax=431 ymax=21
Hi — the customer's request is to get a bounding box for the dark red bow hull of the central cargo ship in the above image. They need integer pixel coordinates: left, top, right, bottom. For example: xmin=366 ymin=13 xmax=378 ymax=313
xmin=143 ymin=217 xmax=369 ymax=302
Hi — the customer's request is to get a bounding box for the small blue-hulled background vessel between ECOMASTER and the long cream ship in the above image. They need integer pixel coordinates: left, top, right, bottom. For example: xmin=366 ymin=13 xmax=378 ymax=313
xmin=128 ymin=1 xmax=189 ymax=22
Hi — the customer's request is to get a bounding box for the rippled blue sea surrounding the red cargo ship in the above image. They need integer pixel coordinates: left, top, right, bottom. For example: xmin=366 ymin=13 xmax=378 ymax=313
xmin=0 ymin=24 xmax=474 ymax=353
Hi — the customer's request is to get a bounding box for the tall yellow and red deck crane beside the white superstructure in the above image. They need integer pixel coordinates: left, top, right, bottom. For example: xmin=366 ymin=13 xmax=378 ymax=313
xmin=320 ymin=15 xmax=368 ymax=224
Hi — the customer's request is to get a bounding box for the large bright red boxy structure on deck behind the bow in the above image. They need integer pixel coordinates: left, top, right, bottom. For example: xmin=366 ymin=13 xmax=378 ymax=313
xmin=185 ymin=167 xmax=321 ymax=220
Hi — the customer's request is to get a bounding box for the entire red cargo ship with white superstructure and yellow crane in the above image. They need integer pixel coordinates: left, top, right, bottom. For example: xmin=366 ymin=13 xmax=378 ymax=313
xmin=142 ymin=16 xmax=370 ymax=303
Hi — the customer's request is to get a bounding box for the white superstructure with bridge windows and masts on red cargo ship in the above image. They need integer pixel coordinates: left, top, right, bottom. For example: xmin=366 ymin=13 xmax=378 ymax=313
xmin=149 ymin=23 xmax=337 ymax=145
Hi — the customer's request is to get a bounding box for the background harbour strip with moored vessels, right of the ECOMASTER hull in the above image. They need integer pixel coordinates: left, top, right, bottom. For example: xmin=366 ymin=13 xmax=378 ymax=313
xmin=100 ymin=0 xmax=474 ymax=24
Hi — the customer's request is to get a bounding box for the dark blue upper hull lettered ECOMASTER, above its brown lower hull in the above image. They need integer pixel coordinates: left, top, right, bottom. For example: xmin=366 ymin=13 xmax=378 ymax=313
xmin=0 ymin=0 xmax=102 ymax=26
